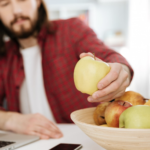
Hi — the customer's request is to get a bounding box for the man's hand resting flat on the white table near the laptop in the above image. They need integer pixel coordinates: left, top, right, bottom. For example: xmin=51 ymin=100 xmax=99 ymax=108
xmin=4 ymin=112 xmax=63 ymax=139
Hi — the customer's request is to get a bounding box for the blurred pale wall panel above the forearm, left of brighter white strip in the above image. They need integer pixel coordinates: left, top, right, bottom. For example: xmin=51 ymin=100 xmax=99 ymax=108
xmin=96 ymin=2 xmax=128 ymax=39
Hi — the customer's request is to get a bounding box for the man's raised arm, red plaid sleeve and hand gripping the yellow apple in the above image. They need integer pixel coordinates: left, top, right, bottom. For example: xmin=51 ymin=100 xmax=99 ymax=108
xmin=71 ymin=19 xmax=133 ymax=102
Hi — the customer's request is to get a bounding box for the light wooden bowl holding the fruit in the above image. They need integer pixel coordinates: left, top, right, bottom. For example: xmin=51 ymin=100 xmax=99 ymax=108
xmin=71 ymin=108 xmax=150 ymax=150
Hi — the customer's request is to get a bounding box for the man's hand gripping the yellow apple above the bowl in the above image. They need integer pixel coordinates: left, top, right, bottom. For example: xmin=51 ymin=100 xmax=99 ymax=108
xmin=80 ymin=53 xmax=131 ymax=102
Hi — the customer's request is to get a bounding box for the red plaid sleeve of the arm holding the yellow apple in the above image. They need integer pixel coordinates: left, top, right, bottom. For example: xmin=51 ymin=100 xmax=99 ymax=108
xmin=70 ymin=18 xmax=134 ymax=79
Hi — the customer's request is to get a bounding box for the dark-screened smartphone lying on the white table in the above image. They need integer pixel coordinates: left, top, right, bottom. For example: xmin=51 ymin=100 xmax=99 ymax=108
xmin=49 ymin=143 xmax=82 ymax=150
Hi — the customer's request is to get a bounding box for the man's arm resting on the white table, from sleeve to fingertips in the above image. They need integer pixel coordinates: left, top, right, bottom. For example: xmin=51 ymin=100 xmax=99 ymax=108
xmin=0 ymin=61 xmax=62 ymax=139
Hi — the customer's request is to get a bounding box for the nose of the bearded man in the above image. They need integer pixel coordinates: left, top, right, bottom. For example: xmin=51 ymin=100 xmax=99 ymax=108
xmin=12 ymin=0 xmax=22 ymax=16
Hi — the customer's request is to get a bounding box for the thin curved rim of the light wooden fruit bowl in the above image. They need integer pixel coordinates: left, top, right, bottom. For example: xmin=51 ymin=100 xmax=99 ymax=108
xmin=70 ymin=107 xmax=150 ymax=132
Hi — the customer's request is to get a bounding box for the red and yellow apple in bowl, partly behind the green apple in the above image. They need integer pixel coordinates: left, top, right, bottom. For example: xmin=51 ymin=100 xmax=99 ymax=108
xmin=105 ymin=100 xmax=132 ymax=128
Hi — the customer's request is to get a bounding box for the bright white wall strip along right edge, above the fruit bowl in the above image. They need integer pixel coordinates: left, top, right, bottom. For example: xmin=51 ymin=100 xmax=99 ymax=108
xmin=126 ymin=0 xmax=150 ymax=98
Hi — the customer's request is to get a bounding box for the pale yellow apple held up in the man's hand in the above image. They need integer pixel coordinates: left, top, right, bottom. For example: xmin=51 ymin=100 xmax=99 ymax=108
xmin=74 ymin=56 xmax=110 ymax=95
